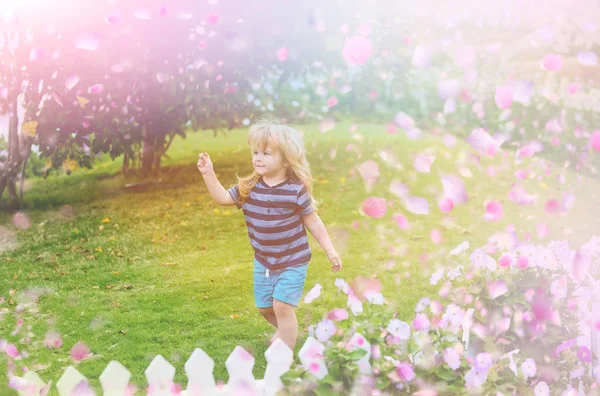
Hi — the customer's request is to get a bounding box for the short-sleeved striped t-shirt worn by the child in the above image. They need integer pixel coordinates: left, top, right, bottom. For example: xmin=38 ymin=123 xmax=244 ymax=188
xmin=227 ymin=177 xmax=313 ymax=270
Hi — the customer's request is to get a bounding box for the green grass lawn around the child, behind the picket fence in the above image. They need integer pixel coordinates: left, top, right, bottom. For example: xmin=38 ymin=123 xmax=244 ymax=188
xmin=0 ymin=124 xmax=598 ymax=394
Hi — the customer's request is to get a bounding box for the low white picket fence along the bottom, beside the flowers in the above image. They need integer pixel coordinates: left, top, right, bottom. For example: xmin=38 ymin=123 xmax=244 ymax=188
xmin=11 ymin=333 xmax=371 ymax=396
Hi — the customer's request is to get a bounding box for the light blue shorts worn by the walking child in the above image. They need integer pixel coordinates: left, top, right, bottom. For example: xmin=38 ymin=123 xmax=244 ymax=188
xmin=254 ymin=259 xmax=308 ymax=308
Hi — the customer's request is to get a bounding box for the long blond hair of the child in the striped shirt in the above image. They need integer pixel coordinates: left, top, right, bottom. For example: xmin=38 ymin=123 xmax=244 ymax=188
xmin=238 ymin=119 xmax=318 ymax=210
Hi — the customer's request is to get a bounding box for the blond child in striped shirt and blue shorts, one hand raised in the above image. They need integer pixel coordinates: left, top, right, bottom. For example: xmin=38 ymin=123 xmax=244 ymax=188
xmin=197 ymin=120 xmax=342 ymax=351
